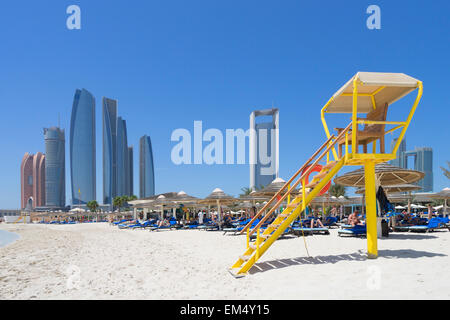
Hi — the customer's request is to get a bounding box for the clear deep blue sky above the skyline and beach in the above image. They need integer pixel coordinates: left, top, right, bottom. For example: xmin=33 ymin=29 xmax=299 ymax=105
xmin=0 ymin=0 xmax=450 ymax=208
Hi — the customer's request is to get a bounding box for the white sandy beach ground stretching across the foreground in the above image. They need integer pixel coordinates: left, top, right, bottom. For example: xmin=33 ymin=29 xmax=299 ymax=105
xmin=0 ymin=223 xmax=450 ymax=299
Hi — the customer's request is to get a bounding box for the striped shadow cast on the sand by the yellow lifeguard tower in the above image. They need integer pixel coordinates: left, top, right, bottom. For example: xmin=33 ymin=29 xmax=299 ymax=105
xmin=249 ymin=249 xmax=447 ymax=274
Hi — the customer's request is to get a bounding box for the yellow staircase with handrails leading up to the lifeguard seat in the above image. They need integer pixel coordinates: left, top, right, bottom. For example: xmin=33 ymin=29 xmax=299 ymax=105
xmin=229 ymin=125 xmax=350 ymax=277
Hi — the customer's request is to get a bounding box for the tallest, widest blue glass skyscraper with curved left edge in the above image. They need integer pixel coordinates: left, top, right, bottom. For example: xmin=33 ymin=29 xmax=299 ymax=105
xmin=70 ymin=89 xmax=97 ymax=205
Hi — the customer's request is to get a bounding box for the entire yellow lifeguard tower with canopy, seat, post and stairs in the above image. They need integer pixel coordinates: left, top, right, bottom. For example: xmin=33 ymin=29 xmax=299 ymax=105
xmin=230 ymin=72 xmax=423 ymax=277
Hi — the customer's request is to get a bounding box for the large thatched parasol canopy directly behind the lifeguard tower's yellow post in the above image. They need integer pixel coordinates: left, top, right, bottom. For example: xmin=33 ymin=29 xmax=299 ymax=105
xmin=334 ymin=163 xmax=425 ymax=188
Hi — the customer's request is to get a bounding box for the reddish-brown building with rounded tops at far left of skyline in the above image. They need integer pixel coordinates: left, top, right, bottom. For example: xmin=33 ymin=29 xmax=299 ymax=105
xmin=20 ymin=152 xmax=45 ymax=209
